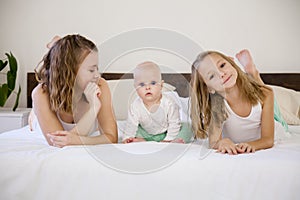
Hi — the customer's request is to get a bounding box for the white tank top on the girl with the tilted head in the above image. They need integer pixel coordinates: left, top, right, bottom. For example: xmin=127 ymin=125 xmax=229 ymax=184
xmin=222 ymin=100 xmax=262 ymax=143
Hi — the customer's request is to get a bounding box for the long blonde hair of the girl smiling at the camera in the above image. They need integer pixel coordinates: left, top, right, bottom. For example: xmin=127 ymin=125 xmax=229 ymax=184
xmin=190 ymin=51 xmax=267 ymax=138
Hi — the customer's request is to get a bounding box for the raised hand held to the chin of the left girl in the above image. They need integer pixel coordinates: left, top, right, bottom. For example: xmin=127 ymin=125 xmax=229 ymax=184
xmin=84 ymin=82 xmax=101 ymax=113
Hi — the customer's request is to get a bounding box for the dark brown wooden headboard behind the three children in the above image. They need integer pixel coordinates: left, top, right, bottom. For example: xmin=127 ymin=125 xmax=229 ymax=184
xmin=27 ymin=72 xmax=300 ymax=108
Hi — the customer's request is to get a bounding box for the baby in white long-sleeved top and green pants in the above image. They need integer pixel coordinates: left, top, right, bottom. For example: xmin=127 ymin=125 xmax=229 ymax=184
xmin=123 ymin=61 xmax=191 ymax=143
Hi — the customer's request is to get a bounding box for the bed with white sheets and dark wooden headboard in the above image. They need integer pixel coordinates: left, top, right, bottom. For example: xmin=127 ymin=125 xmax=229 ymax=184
xmin=0 ymin=73 xmax=300 ymax=200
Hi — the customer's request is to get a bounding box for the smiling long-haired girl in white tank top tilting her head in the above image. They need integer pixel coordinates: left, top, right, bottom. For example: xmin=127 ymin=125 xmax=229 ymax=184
xmin=191 ymin=51 xmax=274 ymax=154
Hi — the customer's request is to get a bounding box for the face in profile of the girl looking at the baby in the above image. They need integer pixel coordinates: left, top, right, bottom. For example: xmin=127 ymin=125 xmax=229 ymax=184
xmin=75 ymin=51 xmax=100 ymax=91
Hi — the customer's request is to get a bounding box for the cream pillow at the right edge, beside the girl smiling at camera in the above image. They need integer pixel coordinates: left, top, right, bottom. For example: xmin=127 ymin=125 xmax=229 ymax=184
xmin=270 ymin=85 xmax=300 ymax=125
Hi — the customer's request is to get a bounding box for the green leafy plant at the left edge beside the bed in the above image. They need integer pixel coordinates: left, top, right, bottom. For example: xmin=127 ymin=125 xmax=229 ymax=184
xmin=0 ymin=52 xmax=21 ymax=111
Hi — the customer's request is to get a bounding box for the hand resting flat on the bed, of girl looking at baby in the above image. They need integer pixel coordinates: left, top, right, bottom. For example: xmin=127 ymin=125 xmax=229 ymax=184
xmin=47 ymin=131 xmax=82 ymax=148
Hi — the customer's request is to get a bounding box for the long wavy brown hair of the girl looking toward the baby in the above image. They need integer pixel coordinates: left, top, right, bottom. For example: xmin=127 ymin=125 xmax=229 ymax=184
xmin=35 ymin=35 xmax=98 ymax=113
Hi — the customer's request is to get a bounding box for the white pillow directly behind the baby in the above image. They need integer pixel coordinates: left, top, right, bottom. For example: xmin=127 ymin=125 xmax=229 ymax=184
xmin=107 ymin=79 xmax=176 ymax=120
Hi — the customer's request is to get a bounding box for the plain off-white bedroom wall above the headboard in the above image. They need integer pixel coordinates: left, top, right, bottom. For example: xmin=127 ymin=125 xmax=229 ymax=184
xmin=0 ymin=0 xmax=300 ymax=107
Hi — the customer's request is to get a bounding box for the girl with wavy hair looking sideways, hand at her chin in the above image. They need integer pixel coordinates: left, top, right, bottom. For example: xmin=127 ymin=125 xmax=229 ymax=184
xmin=31 ymin=35 xmax=117 ymax=147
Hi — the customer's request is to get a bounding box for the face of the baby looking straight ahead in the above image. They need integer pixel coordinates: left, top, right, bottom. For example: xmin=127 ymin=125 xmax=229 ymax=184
xmin=134 ymin=71 xmax=163 ymax=103
